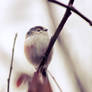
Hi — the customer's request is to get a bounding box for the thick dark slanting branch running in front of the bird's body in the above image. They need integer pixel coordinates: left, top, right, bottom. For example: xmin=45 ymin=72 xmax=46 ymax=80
xmin=38 ymin=0 xmax=74 ymax=71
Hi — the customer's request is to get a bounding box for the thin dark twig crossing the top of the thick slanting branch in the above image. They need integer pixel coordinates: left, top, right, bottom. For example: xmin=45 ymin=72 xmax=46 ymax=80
xmin=48 ymin=0 xmax=92 ymax=26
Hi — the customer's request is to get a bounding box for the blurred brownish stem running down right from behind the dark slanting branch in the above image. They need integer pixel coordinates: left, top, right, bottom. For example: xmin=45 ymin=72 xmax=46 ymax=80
xmin=58 ymin=36 xmax=87 ymax=92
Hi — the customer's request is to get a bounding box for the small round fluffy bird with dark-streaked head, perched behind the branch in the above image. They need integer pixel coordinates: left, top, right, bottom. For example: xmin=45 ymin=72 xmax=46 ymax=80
xmin=24 ymin=26 xmax=52 ymax=68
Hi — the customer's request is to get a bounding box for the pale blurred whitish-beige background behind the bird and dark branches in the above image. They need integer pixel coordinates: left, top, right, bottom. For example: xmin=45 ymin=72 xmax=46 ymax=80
xmin=0 ymin=0 xmax=92 ymax=92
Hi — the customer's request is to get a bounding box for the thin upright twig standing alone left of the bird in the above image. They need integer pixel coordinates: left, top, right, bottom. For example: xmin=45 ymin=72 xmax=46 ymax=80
xmin=7 ymin=33 xmax=17 ymax=92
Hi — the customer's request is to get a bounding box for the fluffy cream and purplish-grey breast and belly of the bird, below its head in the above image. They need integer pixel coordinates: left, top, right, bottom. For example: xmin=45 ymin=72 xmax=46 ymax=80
xmin=24 ymin=33 xmax=49 ymax=65
